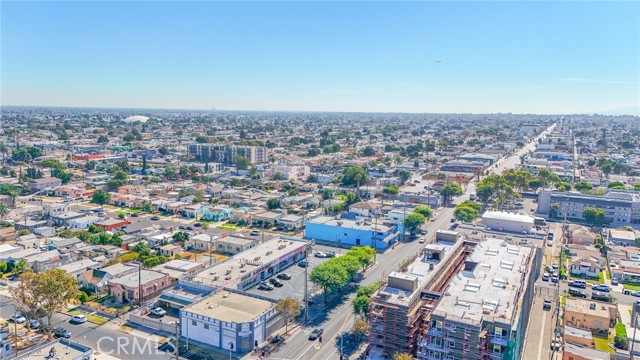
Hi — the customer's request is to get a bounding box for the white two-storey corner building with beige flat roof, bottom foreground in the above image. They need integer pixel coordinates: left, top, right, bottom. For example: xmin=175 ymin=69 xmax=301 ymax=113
xmin=180 ymin=290 xmax=283 ymax=354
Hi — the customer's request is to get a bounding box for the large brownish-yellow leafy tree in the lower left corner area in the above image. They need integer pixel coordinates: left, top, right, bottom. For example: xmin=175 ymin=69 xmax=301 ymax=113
xmin=9 ymin=269 xmax=80 ymax=339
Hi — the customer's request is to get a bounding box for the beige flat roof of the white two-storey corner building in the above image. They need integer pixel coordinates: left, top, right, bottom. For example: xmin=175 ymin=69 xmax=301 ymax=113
xmin=184 ymin=290 xmax=275 ymax=323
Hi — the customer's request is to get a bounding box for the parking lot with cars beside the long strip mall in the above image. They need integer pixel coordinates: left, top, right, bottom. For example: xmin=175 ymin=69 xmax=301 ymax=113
xmin=247 ymin=245 xmax=340 ymax=301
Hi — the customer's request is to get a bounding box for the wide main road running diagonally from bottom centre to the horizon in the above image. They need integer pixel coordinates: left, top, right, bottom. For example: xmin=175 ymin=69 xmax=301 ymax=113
xmin=269 ymin=124 xmax=555 ymax=360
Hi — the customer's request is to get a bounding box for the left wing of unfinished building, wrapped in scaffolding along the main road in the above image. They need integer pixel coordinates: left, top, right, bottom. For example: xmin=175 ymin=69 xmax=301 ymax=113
xmin=369 ymin=234 xmax=474 ymax=358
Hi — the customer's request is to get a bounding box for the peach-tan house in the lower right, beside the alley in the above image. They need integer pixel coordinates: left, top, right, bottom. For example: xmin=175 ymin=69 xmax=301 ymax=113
xmin=564 ymin=298 xmax=618 ymax=332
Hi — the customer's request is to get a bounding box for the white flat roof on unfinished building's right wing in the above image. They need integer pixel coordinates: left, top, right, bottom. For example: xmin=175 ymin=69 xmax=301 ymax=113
xmin=433 ymin=238 xmax=533 ymax=326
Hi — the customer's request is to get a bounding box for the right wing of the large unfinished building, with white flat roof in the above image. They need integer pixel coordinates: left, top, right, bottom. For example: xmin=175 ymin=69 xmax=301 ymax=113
xmin=418 ymin=238 xmax=540 ymax=360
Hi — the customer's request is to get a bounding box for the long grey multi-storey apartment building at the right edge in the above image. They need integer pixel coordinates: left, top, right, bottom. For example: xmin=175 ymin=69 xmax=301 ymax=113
xmin=537 ymin=190 xmax=640 ymax=227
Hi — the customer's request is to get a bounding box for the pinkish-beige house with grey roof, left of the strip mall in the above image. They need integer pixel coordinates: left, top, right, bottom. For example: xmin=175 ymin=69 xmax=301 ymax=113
xmin=107 ymin=270 xmax=172 ymax=303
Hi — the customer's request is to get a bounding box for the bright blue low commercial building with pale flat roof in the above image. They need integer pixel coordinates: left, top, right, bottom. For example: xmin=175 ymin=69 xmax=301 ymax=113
xmin=304 ymin=216 xmax=399 ymax=251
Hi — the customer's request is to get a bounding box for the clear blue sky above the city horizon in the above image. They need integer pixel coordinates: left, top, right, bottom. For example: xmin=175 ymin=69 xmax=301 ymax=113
xmin=0 ymin=1 xmax=640 ymax=113
